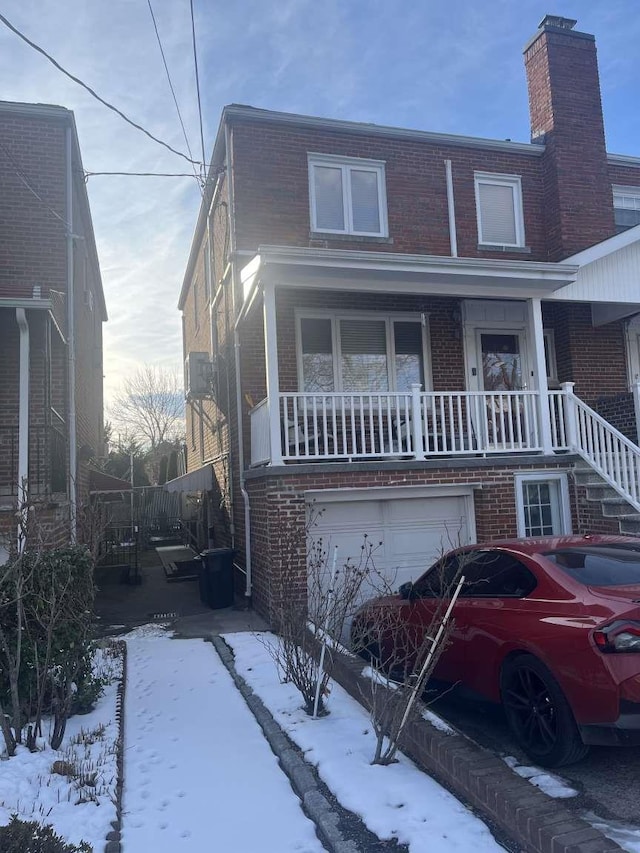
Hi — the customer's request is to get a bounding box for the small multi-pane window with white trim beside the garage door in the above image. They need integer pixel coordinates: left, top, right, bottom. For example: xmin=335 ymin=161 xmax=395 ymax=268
xmin=515 ymin=471 xmax=571 ymax=536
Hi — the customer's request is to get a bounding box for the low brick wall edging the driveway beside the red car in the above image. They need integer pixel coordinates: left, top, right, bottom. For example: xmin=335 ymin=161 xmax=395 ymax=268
xmin=324 ymin=649 xmax=623 ymax=853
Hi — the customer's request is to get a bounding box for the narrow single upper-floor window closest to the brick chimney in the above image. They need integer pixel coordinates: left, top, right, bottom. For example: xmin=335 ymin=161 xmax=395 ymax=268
xmin=474 ymin=172 xmax=524 ymax=246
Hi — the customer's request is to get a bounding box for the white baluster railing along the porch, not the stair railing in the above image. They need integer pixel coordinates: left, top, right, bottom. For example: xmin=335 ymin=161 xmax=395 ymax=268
xmin=251 ymin=385 xmax=559 ymax=465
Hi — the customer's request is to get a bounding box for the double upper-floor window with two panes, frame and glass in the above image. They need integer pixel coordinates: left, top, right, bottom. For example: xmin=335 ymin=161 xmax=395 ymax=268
xmin=309 ymin=154 xmax=388 ymax=237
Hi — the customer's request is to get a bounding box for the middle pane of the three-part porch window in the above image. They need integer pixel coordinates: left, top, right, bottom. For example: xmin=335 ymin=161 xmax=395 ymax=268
xmin=340 ymin=320 xmax=389 ymax=392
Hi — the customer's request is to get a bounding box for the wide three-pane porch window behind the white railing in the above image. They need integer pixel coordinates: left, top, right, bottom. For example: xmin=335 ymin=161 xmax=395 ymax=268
xmin=298 ymin=314 xmax=427 ymax=393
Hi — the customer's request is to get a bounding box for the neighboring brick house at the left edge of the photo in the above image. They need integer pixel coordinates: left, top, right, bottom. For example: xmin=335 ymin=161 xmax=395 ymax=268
xmin=0 ymin=102 xmax=106 ymax=551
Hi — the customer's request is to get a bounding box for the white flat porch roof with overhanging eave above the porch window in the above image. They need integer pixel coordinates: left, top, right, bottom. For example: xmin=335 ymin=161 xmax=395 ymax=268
xmin=241 ymin=246 xmax=578 ymax=320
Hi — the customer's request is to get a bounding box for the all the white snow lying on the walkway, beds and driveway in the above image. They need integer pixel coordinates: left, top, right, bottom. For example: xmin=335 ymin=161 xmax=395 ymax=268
xmin=5 ymin=625 xmax=640 ymax=853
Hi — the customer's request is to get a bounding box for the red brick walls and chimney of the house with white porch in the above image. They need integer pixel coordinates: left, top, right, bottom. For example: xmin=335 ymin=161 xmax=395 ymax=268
xmin=179 ymin=22 xmax=640 ymax=616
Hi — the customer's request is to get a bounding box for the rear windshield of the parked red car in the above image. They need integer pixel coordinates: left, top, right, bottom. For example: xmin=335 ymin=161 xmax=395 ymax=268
xmin=544 ymin=545 xmax=640 ymax=586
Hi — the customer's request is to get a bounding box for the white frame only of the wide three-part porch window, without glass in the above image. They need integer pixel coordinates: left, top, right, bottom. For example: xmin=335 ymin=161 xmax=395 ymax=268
xmin=296 ymin=309 xmax=433 ymax=394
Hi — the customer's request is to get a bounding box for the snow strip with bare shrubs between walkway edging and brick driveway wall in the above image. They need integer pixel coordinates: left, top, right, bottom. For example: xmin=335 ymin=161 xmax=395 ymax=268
xmin=224 ymin=634 xmax=503 ymax=853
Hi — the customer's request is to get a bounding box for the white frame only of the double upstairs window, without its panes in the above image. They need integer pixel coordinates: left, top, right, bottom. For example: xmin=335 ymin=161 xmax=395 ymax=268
xmin=307 ymin=153 xmax=389 ymax=237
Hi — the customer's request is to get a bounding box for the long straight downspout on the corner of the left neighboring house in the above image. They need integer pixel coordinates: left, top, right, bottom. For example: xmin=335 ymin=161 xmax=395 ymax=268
xmin=65 ymin=127 xmax=78 ymax=544
